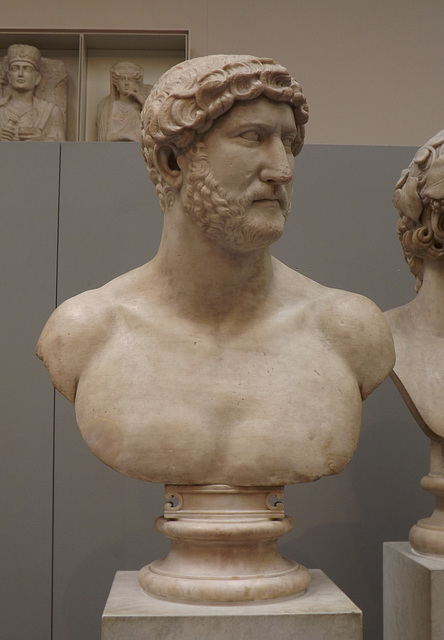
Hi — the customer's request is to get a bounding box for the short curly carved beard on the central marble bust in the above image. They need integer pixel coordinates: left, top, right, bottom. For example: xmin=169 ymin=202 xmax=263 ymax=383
xmin=180 ymin=152 xmax=290 ymax=251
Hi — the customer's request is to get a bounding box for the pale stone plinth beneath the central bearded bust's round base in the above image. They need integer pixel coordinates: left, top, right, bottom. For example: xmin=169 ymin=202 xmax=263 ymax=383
xmin=102 ymin=569 xmax=362 ymax=640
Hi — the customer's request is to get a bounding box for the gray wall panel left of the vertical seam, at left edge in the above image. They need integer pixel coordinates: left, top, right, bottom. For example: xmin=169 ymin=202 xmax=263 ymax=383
xmin=0 ymin=143 xmax=60 ymax=640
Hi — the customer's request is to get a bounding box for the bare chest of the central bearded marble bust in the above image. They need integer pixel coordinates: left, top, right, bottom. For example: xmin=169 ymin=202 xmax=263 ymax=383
xmin=76 ymin=318 xmax=361 ymax=484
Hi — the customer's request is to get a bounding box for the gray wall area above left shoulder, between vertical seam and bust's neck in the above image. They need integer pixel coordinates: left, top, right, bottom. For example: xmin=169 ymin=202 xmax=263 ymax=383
xmin=58 ymin=142 xmax=162 ymax=304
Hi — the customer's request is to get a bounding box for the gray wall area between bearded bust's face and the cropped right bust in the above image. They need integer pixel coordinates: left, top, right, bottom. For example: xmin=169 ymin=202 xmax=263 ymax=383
xmin=273 ymin=145 xmax=415 ymax=309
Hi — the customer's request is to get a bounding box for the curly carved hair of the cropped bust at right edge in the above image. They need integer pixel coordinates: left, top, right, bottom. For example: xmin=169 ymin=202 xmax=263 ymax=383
xmin=393 ymin=130 xmax=444 ymax=292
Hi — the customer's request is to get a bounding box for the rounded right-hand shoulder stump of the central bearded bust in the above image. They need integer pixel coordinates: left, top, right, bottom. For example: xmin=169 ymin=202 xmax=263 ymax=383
xmin=319 ymin=289 xmax=395 ymax=399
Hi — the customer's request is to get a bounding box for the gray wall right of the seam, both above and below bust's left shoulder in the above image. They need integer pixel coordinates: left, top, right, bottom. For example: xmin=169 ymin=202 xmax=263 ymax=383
xmin=54 ymin=143 xmax=167 ymax=640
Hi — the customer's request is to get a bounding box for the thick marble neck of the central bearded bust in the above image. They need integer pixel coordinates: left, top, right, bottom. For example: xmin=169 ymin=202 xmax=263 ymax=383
xmin=152 ymin=201 xmax=273 ymax=324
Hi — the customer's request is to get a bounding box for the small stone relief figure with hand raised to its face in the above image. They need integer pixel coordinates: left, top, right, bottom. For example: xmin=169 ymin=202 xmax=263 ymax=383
xmin=97 ymin=62 xmax=152 ymax=142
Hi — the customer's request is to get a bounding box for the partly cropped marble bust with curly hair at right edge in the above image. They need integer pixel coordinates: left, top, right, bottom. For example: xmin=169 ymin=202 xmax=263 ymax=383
xmin=385 ymin=130 xmax=444 ymax=556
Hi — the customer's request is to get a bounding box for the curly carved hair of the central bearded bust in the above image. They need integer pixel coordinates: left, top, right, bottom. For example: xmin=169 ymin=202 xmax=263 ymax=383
xmin=141 ymin=55 xmax=308 ymax=211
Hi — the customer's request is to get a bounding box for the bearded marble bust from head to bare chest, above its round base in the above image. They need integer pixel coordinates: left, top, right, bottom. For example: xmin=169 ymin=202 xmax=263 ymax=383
xmin=37 ymin=55 xmax=394 ymax=599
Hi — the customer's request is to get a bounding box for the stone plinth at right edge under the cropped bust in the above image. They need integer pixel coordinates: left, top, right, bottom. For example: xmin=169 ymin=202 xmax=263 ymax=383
xmin=384 ymin=542 xmax=444 ymax=640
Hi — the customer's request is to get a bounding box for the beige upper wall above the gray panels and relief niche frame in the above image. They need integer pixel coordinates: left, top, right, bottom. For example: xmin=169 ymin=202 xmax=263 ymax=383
xmin=1 ymin=0 xmax=444 ymax=146
